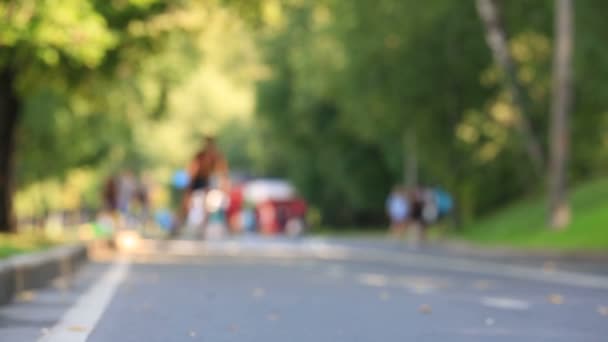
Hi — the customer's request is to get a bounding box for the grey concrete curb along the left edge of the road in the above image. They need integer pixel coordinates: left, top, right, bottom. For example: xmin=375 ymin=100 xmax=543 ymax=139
xmin=0 ymin=244 xmax=88 ymax=305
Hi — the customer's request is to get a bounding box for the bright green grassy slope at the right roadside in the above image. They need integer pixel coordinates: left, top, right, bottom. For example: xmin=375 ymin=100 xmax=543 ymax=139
xmin=456 ymin=179 xmax=608 ymax=251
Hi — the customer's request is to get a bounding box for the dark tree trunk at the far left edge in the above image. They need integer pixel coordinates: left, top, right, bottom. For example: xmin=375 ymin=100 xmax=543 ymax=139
xmin=0 ymin=67 xmax=19 ymax=232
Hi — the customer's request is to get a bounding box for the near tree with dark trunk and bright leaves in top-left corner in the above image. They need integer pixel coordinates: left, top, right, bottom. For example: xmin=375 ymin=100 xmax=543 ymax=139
xmin=0 ymin=0 xmax=115 ymax=231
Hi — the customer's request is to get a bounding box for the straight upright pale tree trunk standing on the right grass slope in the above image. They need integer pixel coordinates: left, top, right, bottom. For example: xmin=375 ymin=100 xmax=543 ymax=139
xmin=549 ymin=0 xmax=574 ymax=229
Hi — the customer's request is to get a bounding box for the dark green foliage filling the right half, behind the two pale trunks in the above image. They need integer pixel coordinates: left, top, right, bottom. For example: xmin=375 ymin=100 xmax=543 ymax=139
xmin=257 ymin=0 xmax=608 ymax=224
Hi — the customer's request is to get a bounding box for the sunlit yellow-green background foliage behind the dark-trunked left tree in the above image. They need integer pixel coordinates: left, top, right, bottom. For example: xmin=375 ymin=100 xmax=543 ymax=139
xmin=8 ymin=1 xmax=258 ymax=216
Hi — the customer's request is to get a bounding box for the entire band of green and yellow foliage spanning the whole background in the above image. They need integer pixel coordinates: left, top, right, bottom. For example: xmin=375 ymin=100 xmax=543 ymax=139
xmin=7 ymin=0 xmax=608 ymax=235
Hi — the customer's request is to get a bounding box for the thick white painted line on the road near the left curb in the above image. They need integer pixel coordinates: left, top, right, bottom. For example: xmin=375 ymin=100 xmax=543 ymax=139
xmin=38 ymin=259 xmax=129 ymax=342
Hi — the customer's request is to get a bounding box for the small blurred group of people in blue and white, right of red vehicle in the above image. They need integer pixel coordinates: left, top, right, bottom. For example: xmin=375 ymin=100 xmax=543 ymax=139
xmin=386 ymin=185 xmax=453 ymax=240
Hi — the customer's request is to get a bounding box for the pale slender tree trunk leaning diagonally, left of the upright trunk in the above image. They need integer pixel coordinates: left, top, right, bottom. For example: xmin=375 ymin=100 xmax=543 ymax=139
xmin=477 ymin=0 xmax=545 ymax=177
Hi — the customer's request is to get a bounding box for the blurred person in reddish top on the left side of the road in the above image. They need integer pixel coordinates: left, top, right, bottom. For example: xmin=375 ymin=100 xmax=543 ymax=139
xmin=172 ymin=136 xmax=230 ymax=236
